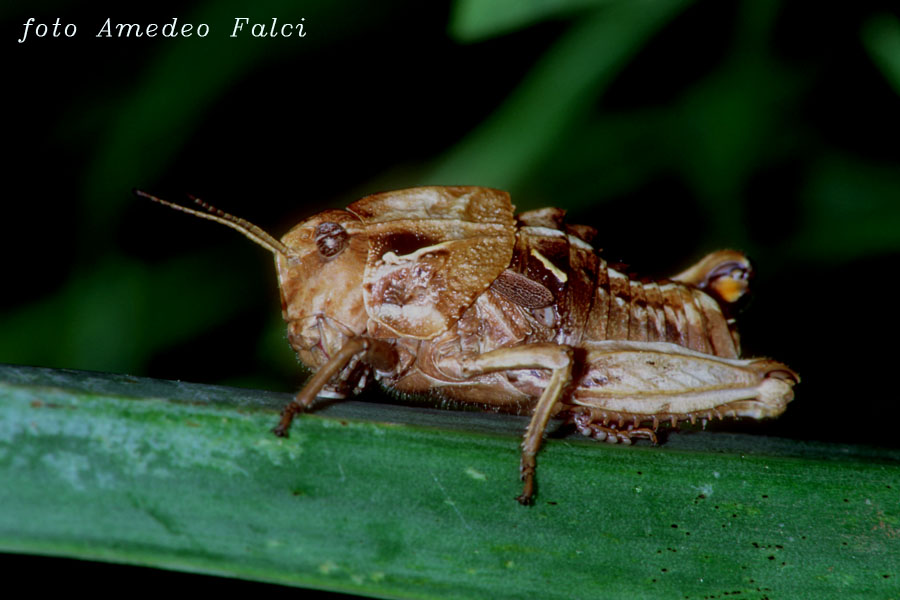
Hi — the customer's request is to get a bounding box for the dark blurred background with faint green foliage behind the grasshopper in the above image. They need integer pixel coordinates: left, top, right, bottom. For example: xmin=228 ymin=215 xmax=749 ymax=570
xmin=0 ymin=0 xmax=900 ymax=444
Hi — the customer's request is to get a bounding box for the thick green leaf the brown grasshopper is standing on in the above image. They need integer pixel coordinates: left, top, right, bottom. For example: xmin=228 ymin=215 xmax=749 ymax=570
xmin=0 ymin=366 xmax=900 ymax=599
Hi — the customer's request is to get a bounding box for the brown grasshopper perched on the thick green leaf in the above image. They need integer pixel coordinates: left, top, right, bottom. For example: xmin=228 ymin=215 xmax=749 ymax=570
xmin=137 ymin=187 xmax=799 ymax=504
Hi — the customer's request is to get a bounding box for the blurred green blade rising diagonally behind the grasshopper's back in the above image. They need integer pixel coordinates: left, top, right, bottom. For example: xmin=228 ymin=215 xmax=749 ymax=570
xmin=423 ymin=0 xmax=686 ymax=191
